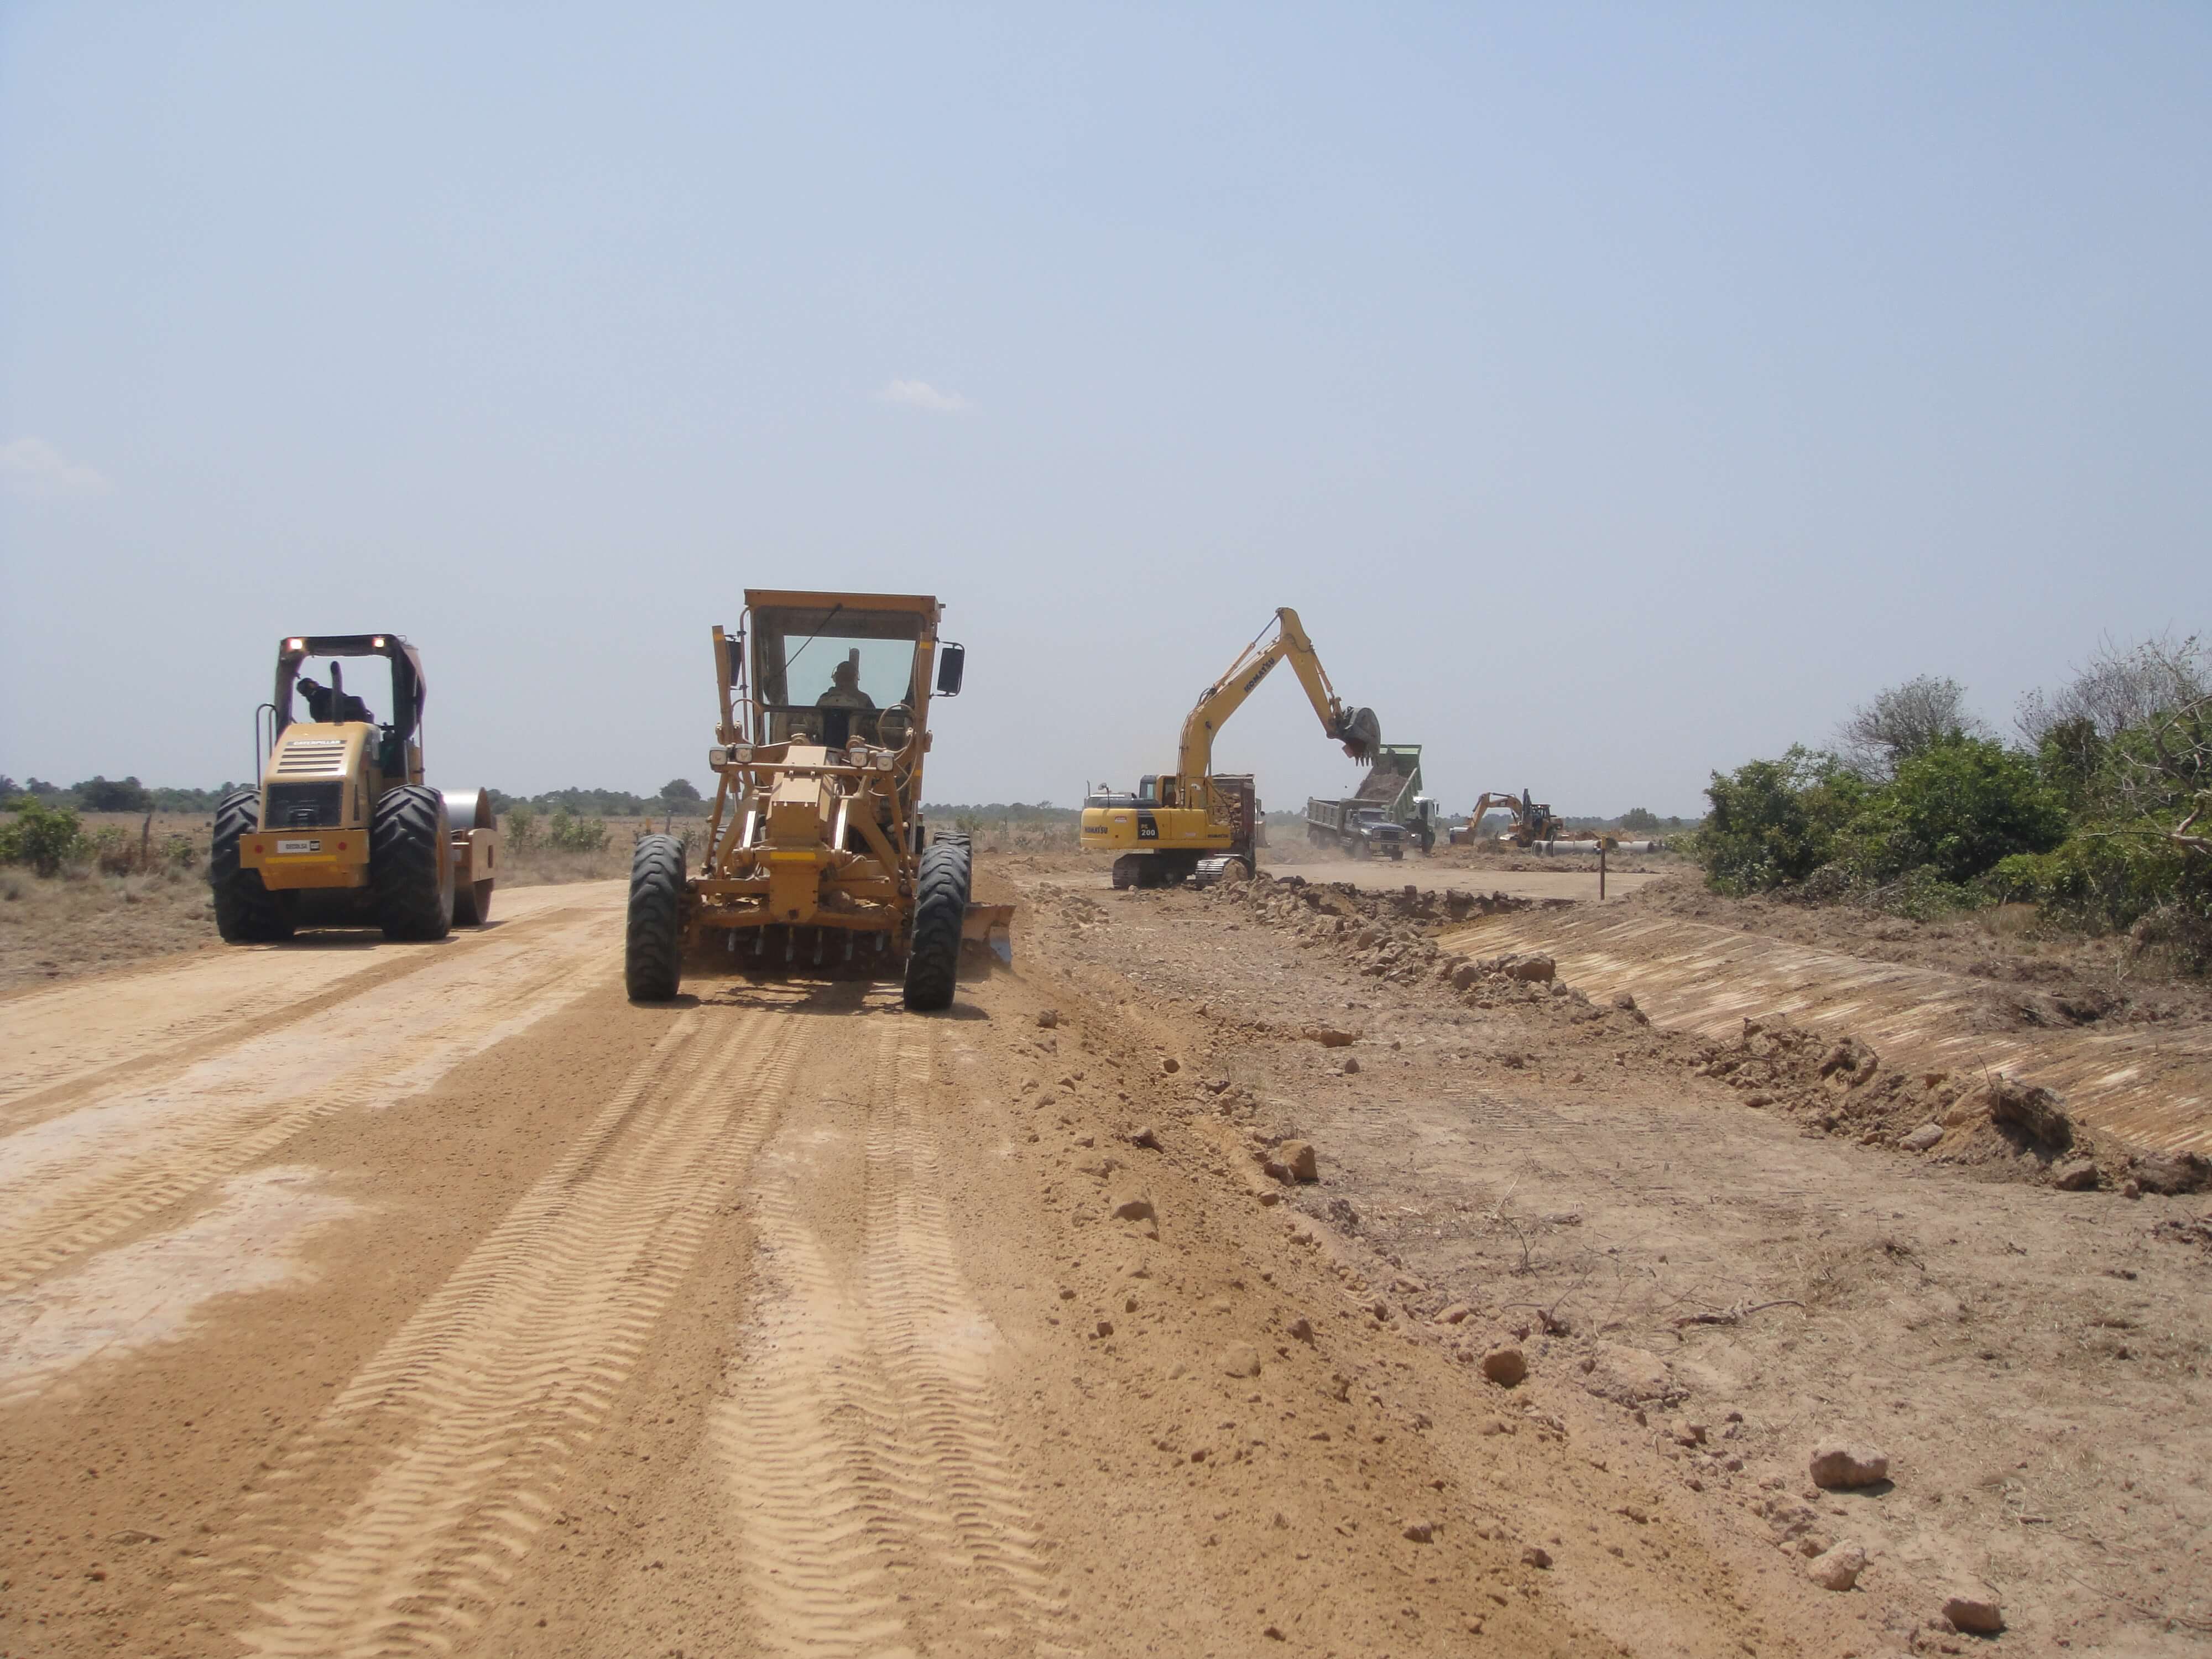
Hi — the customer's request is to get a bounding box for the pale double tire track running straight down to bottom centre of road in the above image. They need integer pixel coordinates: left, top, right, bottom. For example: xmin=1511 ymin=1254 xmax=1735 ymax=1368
xmin=712 ymin=1022 xmax=1066 ymax=1655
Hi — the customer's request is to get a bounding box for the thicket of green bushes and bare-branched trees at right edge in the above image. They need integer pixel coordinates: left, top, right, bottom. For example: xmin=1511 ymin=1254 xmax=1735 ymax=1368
xmin=1699 ymin=637 xmax=2212 ymax=971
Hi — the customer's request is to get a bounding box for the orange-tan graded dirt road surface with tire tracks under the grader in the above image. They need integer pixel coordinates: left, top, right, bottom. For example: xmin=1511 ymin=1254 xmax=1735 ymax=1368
xmin=0 ymin=887 xmax=1772 ymax=1655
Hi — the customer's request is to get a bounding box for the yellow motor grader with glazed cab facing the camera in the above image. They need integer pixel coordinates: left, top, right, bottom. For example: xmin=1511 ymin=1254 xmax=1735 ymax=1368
xmin=624 ymin=588 xmax=1013 ymax=1011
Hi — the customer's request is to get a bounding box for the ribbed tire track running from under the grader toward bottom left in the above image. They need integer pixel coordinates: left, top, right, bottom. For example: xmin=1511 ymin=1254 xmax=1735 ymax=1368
xmin=192 ymin=1009 xmax=796 ymax=1655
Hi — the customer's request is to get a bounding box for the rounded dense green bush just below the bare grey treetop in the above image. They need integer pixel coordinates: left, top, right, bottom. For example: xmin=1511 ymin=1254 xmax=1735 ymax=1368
xmin=1836 ymin=737 xmax=2068 ymax=887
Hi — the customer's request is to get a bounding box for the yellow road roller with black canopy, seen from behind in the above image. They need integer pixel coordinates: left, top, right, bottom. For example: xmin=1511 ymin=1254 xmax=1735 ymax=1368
xmin=210 ymin=633 xmax=500 ymax=945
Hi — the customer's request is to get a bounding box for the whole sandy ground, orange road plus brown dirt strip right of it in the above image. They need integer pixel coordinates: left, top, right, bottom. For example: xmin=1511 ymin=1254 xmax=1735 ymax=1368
xmin=0 ymin=858 xmax=2212 ymax=1657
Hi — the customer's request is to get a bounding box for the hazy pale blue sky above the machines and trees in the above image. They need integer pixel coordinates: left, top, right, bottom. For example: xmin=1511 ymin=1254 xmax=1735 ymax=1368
xmin=0 ymin=0 xmax=2212 ymax=812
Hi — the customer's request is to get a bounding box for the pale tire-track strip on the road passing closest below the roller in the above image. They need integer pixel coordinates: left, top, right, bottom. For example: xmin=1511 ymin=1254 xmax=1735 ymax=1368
xmin=0 ymin=900 xmax=611 ymax=1128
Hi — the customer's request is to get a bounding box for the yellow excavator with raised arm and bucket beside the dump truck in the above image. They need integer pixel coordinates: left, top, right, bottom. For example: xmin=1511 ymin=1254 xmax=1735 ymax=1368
xmin=1082 ymin=608 xmax=1383 ymax=887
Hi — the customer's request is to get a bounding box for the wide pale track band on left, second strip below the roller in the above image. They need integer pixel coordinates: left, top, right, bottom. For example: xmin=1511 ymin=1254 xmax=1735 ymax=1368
xmin=0 ymin=918 xmax=611 ymax=1294
